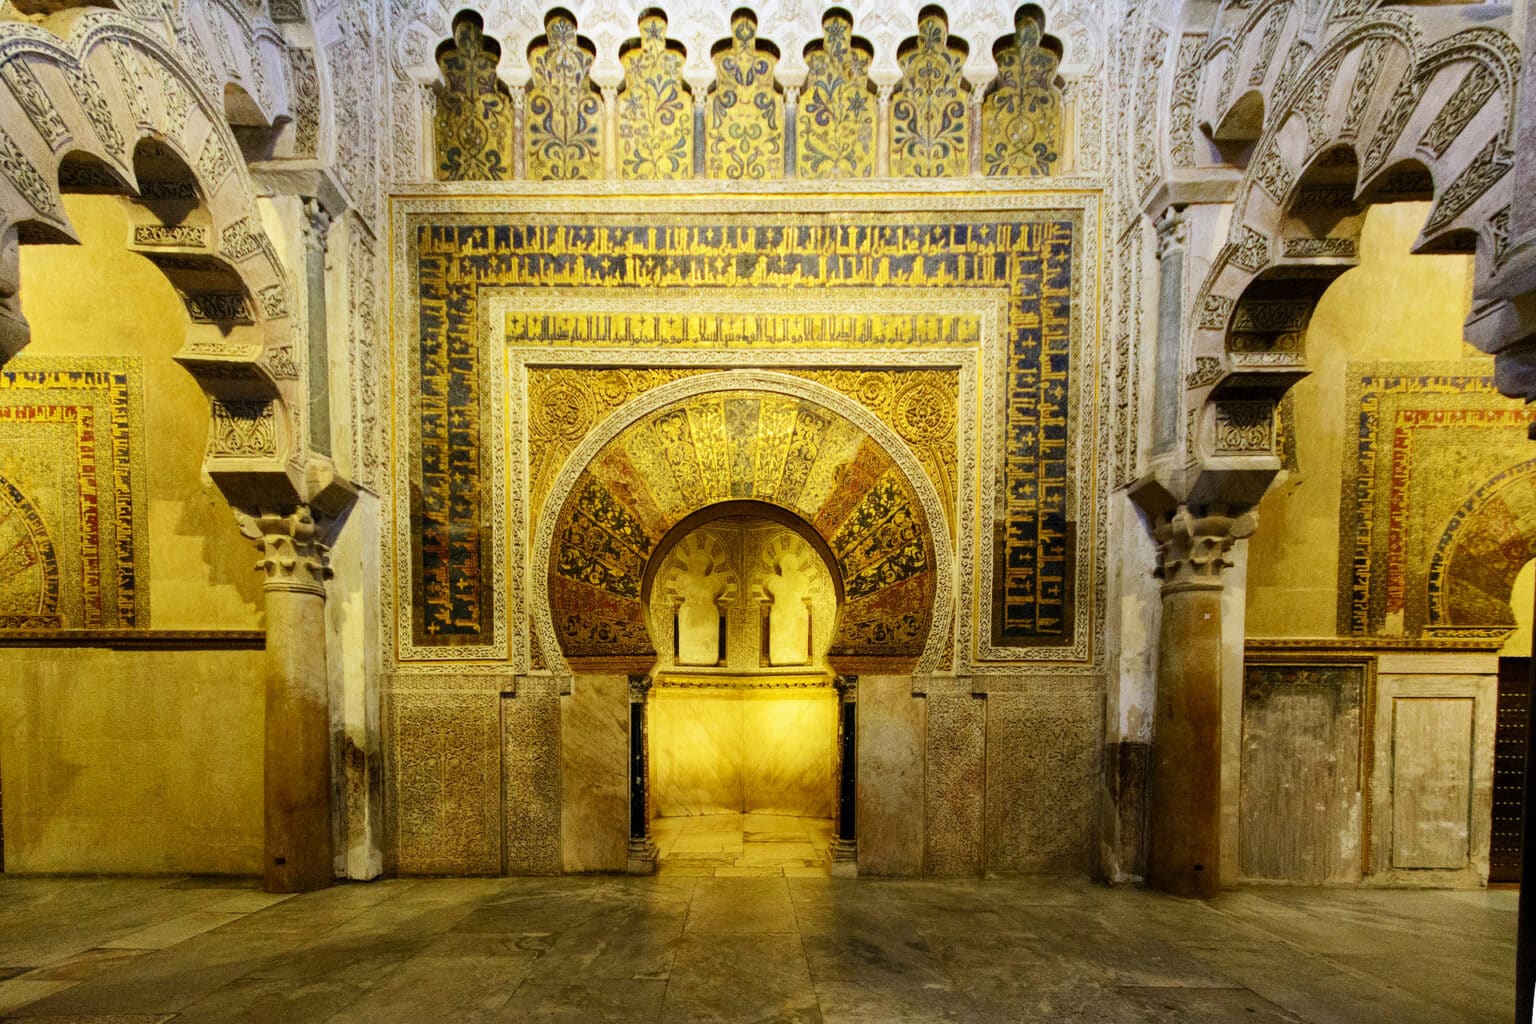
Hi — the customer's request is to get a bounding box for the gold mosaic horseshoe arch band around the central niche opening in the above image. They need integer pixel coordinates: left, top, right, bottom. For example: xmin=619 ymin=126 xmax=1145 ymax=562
xmin=530 ymin=370 xmax=954 ymax=672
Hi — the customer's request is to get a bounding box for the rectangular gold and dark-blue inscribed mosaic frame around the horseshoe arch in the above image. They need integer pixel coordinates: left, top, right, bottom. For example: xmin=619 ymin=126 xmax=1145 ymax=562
xmin=393 ymin=193 xmax=1103 ymax=671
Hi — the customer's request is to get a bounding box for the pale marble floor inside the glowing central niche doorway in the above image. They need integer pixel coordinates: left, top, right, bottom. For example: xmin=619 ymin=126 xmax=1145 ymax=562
xmin=651 ymin=814 xmax=833 ymax=878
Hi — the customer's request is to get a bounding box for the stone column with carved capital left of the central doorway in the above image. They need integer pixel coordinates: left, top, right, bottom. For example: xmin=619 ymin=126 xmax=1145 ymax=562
xmin=237 ymin=505 xmax=333 ymax=892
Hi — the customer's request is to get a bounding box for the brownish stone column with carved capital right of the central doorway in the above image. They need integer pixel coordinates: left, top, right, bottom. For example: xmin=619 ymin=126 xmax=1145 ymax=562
xmin=1147 ymin=505 xmax=1258 ymax=900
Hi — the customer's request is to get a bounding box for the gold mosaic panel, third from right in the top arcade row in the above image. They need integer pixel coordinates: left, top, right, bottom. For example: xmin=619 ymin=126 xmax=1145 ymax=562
xmin=796 ymin=14 xmax=876 ymax=178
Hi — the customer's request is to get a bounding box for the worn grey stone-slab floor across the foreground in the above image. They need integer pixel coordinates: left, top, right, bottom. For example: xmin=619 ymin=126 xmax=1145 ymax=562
xmin=0 ymin=872 xmax=1516 ymax=1024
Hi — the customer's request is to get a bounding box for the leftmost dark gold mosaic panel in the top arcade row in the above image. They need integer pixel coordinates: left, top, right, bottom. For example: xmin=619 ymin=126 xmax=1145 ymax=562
xmin=433 ymin=17 xmax=513 ymax=181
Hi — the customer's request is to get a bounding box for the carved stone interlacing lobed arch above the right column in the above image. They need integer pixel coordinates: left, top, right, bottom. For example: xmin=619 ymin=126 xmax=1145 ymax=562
xmin=1130 ymin=0 xmax=1521 ymax=491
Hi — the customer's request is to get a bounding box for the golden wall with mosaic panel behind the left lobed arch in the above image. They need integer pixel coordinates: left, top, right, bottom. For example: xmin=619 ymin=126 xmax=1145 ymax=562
xmin=0 ymin=195 xmax=263 ymax=872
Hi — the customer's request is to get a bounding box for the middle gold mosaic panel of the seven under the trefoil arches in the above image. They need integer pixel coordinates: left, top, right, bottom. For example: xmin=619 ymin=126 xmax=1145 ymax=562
xmin=703 ymin=11 xmax=783 ymax=180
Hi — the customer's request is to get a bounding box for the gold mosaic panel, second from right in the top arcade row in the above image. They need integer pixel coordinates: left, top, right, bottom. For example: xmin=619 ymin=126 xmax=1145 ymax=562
xmin=891 ymin=14 xmax=971 ymax=178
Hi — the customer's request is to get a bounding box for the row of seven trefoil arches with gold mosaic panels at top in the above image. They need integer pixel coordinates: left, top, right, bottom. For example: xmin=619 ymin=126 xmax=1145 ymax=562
xmin=417 ymin=3 xmax=1069 ymax=181
